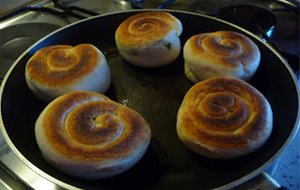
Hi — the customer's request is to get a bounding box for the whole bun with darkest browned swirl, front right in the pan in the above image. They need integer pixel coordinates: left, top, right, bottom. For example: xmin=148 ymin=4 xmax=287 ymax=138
xmin=177 ymin=77 xmax=273 ymax=159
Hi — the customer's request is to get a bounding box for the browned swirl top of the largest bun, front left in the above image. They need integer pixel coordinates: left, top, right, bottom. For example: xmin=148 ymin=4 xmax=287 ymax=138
xmin=41 ymin=92 xmax=150 ymax=162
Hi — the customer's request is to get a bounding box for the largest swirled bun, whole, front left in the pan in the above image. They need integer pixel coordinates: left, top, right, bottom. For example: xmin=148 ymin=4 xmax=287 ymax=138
xmin=35 ymin=91 xmax=151 ymax=179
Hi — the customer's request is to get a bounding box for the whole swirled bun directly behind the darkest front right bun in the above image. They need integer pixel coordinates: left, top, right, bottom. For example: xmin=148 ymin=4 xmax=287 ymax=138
xmin=183 ymin=31 xmax=260 ymax=82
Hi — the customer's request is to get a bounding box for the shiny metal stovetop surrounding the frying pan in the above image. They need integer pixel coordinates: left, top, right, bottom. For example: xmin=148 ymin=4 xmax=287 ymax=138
xmin=0 ymin=0 xmax=300 ymax=189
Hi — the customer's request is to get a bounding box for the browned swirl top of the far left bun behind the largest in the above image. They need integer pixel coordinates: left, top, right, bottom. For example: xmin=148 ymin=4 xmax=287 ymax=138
xmin=26 ymin=44 xmax=101 ymax=86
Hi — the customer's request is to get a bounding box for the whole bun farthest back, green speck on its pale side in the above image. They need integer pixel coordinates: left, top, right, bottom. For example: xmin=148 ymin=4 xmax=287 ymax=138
xmin=115 ymin=11 xmax=182 ymax=68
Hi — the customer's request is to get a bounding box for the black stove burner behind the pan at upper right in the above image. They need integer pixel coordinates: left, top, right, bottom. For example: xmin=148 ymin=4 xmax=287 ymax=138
xmin=216 ymin=4 xmax=300 ymax=75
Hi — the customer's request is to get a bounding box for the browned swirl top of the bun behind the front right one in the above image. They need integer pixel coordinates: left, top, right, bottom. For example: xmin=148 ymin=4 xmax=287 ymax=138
xmin=186 ymin=31 xmax=257 ymax=67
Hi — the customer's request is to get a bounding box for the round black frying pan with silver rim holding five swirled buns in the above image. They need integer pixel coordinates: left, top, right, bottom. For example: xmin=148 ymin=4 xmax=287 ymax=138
xmin=0 ymin=10 xmax=299 ymax=189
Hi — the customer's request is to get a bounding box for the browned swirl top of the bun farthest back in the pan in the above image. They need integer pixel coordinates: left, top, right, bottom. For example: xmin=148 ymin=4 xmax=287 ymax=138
xmin=116 ymin=11 xmax=182 ymax=46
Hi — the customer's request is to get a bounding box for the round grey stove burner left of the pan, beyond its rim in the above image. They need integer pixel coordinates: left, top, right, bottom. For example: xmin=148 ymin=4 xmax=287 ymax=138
xmin=0 ymin=23 xmax=60 ymax=81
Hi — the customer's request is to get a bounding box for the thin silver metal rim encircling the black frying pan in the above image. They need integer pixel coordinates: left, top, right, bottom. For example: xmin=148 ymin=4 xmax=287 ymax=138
xmin=0 ymin=9 xmax=300 ymax=189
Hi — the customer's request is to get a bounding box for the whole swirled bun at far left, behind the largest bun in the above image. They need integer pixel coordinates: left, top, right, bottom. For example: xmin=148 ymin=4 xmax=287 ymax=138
xmin=25 ymin=44 xmax=111 ymax=102
